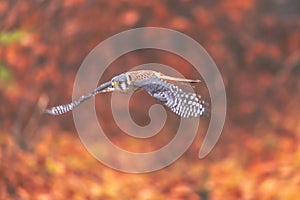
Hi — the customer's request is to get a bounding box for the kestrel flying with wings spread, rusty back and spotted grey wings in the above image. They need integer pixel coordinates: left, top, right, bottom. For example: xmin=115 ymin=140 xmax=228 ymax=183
xmin=44 ymin=70 xmax=209 ymax=118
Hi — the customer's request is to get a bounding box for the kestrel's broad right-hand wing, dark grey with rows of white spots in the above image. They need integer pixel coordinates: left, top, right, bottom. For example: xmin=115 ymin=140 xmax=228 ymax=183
xmin=137 ymin=78 xmax=209 ymax=118
